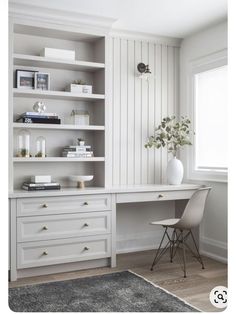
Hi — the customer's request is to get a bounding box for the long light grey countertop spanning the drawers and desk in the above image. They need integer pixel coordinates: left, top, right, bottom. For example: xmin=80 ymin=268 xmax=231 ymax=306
xmin=9 ymin=184 xmax=201 ymax=198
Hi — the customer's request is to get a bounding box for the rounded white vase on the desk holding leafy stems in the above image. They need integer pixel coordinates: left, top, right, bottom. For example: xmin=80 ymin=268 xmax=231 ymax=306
xmin=167 ymin=157 xmax=184 ymax=185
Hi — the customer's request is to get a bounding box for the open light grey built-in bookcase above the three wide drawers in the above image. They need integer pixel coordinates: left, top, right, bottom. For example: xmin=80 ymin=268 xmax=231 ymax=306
xmin=9 ymin=22 xmax=107 ymax=191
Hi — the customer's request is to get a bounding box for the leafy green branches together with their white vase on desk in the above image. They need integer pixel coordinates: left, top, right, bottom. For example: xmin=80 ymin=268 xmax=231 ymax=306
xmin=145 ymin=116 xmax=192 ymax=184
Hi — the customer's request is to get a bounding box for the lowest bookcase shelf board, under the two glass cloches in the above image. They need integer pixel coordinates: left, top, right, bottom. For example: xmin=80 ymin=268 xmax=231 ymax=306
xmin=13 ymin=157 xmax=105 ymax=163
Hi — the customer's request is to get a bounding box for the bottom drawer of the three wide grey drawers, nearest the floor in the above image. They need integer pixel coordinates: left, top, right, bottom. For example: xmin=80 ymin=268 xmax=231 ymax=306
xmin=17 ymin=235 xmax=111 ymax=269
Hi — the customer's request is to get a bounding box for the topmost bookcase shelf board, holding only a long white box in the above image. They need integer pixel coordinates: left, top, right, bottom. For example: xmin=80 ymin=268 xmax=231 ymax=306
xmin=13 ymin=53 xmax=105 ymax=72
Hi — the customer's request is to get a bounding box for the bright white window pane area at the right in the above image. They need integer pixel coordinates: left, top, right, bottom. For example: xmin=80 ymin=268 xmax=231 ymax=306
xmin=194 ymin=66 xmax=227 ymax=171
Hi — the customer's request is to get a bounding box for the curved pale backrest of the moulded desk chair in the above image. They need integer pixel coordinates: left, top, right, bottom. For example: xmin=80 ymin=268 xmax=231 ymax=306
xmin=176 ymin=187 xmax=211 ymax=229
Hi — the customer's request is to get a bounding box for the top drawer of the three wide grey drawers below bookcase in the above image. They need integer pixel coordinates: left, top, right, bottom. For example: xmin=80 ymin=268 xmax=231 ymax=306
xmin=17 ymin=194 xmax=111 ymax=216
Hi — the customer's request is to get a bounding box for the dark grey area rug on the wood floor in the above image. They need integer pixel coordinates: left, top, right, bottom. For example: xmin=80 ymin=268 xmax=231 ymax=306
xmin=9 ymin=271 xmax=198 ymax=312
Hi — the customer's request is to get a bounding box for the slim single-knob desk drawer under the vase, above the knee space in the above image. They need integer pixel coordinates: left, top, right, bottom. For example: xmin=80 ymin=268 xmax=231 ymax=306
xmin=116 ymin=190 xmax=196 ymax=203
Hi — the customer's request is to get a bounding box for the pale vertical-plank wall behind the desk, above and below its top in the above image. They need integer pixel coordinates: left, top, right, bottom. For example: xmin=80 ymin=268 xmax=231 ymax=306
xmin=109 ymin=36 xmax=179 ymax=252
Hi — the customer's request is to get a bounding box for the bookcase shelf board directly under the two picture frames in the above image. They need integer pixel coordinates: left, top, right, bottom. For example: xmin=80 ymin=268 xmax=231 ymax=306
xmin=13 ymin=88 xmax=105 ymax=101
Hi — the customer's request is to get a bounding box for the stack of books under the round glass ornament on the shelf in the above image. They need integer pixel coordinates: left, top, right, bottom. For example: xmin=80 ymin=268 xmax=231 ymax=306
xmin=16 ymin=112 xmax=61 ymax=124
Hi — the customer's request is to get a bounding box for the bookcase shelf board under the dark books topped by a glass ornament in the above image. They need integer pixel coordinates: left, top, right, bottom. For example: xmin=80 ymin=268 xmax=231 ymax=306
xmin=13 ymin=122 xmax=105 ymax=131
